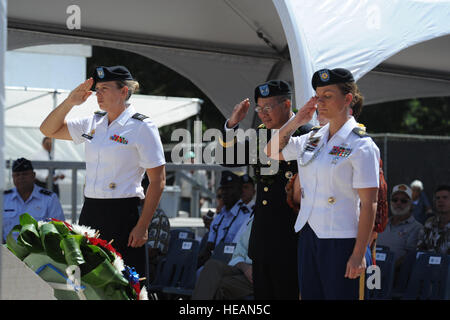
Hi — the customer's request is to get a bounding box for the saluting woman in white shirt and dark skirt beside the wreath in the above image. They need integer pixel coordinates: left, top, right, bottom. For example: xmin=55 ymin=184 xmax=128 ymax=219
xmin=40 ymin=66 xmax=165 ymax=275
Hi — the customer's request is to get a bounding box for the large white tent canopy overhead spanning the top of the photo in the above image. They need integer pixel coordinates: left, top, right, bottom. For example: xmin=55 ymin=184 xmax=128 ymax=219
xmin=4 ymin=0 xmax=450 ymax=127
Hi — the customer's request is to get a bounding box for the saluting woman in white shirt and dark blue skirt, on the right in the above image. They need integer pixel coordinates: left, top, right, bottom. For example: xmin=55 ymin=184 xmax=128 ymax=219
xmin=265 ymin=68 xmax=380 ymax=299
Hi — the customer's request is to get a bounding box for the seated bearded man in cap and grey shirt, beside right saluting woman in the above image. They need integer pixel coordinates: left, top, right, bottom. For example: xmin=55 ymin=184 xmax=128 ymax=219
xmin=377 ymin=184 xmax=422 ymax=266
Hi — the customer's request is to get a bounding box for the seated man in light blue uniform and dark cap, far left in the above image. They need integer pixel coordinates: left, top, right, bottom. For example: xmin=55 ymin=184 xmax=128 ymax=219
xmin=3 ymin=158 xmax=64 ymax=240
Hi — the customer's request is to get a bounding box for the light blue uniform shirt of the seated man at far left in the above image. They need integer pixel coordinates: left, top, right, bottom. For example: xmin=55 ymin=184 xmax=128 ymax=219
xmin=3 ymin=185 xmax=65 ymax=239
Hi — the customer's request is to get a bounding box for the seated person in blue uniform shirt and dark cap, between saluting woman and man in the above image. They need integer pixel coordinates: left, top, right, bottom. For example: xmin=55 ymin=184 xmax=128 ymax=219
xmin=198 ymin=171 xmax=250 ymax=267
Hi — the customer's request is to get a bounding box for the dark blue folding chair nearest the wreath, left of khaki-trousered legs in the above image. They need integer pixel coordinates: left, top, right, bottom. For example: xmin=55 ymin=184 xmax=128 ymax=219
xmin=149 ymin=239 xmax=199 ymax=296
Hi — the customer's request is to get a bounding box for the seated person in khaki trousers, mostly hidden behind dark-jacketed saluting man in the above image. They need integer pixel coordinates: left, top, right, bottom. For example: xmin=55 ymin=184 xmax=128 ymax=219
xmin=191 ymin=218 xmax=253 ymax=300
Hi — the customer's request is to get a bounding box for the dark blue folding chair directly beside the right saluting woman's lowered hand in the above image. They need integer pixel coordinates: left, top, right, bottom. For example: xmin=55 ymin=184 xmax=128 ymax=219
xmin=366 ymin=247 xmax=395 ymax=300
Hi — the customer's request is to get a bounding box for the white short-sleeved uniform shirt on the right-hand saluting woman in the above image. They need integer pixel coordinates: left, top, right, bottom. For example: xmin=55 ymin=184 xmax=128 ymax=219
xmin=282 ymin=117 xmax=380 ymax=238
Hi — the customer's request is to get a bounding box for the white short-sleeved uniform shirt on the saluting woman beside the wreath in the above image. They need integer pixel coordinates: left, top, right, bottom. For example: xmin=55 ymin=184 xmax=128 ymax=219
xmin=67 ymin=106 xmax=166 ymax=199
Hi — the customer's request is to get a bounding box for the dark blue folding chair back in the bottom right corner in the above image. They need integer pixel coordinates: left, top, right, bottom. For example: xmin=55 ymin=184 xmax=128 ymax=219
xmin=403 ymin=253 xmax=448 ymax=300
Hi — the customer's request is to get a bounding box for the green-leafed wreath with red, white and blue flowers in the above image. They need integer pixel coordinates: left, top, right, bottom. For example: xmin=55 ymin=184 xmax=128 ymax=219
xmin=6 ymin=213 xmax=147 ymax=300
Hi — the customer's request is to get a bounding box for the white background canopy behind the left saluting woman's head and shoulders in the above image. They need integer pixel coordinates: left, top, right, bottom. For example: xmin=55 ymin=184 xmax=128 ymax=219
xmin=4 ymin=87 xmax=202 ymax=161
